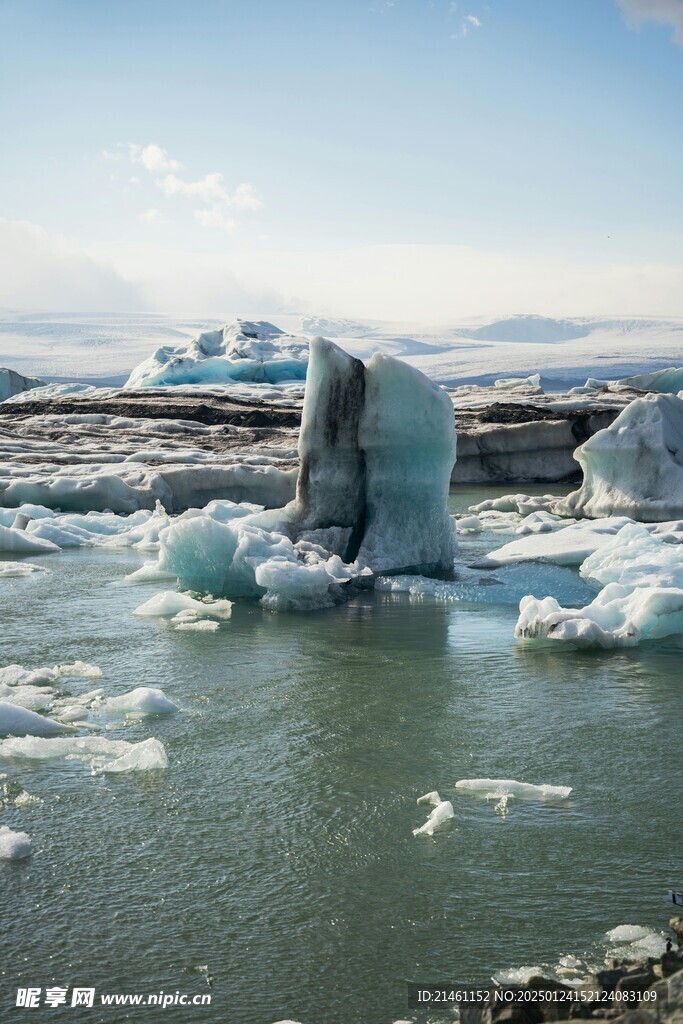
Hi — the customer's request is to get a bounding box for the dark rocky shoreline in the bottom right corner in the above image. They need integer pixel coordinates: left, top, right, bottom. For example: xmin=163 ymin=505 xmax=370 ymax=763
xmin=460 ymin=916 xmax=683 ymax=1024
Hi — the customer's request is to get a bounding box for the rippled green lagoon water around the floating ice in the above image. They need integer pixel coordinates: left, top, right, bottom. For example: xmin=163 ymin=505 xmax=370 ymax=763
xmin=0 ymin=492 xmax=683 ymax=1024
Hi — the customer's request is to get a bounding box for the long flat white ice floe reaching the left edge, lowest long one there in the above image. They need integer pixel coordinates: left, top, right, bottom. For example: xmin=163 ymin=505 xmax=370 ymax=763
xmin=0 ymin=736 xmax=168 ymax=773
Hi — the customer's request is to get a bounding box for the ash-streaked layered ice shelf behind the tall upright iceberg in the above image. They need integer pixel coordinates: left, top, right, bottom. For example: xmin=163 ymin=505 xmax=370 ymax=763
xmin=0 ymin=378 xmax=634 ymax=513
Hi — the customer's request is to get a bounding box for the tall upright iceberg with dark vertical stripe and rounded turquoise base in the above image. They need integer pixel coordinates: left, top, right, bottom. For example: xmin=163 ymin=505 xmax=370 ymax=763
xmin=152 ymin=338 xmax=456 ymax=610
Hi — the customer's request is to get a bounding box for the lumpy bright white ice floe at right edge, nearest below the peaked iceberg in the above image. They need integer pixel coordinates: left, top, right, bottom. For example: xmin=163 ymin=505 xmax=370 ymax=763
xmin=515 ymin=522 xmax=683 ymax=648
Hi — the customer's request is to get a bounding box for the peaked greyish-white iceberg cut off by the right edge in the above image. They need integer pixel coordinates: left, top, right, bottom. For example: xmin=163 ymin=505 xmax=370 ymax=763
xmin=555 ymin=394 xmax=683 ymax=522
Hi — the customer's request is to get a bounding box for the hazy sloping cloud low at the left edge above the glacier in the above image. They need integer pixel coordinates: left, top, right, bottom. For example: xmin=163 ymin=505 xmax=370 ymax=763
xmin=0 ymin=218 xmax=144 ymax=311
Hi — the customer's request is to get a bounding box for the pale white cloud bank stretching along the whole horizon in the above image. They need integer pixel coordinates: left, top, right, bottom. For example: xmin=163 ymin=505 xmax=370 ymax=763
xmin=0 ymin=218 xmax=683 ymax=324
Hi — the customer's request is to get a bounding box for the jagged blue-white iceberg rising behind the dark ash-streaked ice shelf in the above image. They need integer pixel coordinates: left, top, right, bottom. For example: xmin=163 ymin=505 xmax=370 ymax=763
xmin=125 ymin=319 xmax=308 ymax=388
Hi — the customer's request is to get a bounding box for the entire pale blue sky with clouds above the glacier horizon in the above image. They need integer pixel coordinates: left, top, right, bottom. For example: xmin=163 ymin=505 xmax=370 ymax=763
xmin=0 ymin=0 xmax=683 ymax=323
